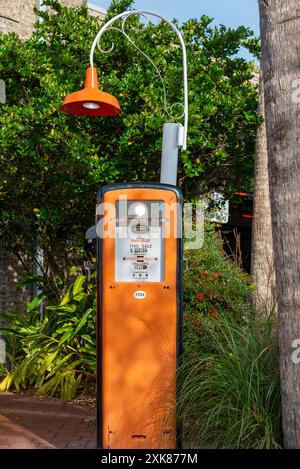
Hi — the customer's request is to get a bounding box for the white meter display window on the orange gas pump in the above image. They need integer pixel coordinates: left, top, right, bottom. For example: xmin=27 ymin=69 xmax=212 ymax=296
xmin=115 ymin=200 xmax=164 ymax=282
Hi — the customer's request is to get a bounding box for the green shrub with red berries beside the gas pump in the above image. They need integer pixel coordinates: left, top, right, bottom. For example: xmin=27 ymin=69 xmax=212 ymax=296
xmin=183 ymin=224 xmax=253 ymax=350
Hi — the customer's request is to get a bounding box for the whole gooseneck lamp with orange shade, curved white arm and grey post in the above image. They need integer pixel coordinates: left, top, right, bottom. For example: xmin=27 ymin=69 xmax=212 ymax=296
xmin=61 ymin=10 xmax=188 ymax=185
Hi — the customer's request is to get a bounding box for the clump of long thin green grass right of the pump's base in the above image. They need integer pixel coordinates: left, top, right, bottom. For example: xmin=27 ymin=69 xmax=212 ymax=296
xmin=178 ymin=313 xmax=282 ymax=449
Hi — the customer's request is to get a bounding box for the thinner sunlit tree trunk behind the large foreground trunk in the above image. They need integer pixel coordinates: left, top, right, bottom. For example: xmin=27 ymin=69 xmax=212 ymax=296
xmin=251 ymin=74 xmax=276 ymax=312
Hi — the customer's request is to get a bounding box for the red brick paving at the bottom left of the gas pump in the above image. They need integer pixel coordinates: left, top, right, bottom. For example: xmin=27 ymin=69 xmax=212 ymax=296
xmin=0 ymin=393 xmax=96 ymax=449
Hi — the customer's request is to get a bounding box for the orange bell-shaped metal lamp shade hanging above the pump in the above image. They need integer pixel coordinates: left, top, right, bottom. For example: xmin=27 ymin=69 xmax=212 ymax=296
xmin=61 ymin=66 xmax=122 ymax=116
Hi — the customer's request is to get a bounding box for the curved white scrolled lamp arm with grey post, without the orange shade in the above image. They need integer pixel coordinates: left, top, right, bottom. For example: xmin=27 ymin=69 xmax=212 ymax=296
xmin=90 ymin=10 xmax=188 ymax=185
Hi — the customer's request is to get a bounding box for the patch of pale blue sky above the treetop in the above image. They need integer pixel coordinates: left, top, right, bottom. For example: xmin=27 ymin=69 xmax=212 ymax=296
xmin=91 ymin=0 xmax=259 ymax=35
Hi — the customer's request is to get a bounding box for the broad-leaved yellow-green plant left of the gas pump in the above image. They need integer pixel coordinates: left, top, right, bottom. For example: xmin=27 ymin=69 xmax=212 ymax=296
xmin=0 ymin=266 xmax=96 ymax=400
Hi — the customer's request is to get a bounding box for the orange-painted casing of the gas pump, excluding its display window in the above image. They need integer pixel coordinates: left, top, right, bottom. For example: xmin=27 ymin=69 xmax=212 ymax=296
xmin=99 ymin=188 xmax=180 ymax=449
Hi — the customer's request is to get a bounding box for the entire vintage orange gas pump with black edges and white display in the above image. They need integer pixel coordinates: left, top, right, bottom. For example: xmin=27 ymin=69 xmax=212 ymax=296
xmin=97 ymin=183 xmax=182 ymax=449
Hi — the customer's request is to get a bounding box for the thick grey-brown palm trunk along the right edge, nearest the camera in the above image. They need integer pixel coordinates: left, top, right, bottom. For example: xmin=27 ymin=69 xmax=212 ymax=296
xmin=259 ymin=0 xmax=300 ymax=448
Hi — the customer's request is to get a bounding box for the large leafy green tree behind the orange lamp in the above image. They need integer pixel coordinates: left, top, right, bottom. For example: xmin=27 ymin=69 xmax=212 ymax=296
xmin=0 ymin=0 xmax=258 ymax=284
